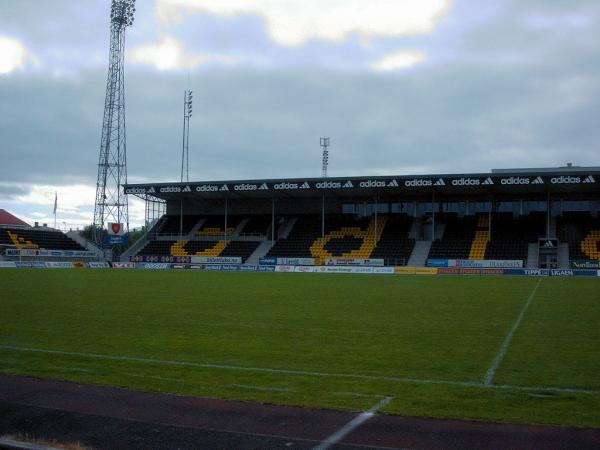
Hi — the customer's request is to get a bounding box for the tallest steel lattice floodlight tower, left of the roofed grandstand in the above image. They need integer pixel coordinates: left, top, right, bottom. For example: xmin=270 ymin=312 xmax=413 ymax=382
xmin=94 ymin=0 xmax=135 ymax=246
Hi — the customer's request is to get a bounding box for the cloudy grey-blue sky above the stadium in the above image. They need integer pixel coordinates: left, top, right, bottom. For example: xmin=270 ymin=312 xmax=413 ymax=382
xmin=0 ymin=0 xmax=600 ymax=227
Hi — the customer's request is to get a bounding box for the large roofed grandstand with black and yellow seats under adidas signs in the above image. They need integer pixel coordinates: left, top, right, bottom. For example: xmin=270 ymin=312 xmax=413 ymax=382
xmin=123 ymin=165 xmax=600 ymax=268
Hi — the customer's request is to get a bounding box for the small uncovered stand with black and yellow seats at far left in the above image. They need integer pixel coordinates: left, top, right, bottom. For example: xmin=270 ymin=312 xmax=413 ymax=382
xmin=0 ymin=209 xmax=97 ymax=261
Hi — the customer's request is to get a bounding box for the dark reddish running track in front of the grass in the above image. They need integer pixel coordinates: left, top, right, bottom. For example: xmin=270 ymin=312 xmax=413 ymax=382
xmin=0 ymin=375 xmax=600 ymax=450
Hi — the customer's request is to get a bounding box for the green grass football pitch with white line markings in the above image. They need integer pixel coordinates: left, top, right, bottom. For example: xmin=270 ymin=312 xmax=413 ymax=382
xmin=0 ymin=270 xmax=600 ymax=427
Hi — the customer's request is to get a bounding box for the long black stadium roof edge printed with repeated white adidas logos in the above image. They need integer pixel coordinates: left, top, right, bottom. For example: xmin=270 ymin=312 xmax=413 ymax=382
xmin=125 ymin=167 xmax=600 ymax=200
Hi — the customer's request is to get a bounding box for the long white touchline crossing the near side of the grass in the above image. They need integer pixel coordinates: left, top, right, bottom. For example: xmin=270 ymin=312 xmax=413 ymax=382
xmin=0 ymin=345 xmax=600 ymax=395
